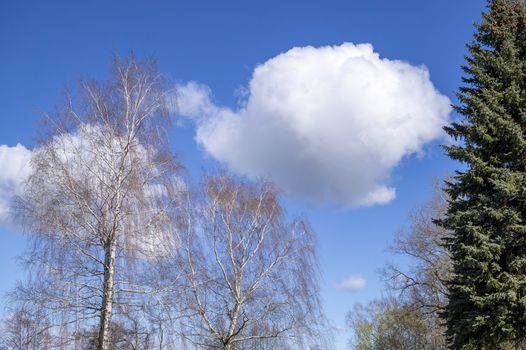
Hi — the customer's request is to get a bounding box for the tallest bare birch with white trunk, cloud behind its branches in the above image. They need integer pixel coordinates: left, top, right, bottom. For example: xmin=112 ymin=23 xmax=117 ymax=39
xmin=17 ymin=57 xmax=178 ymax=350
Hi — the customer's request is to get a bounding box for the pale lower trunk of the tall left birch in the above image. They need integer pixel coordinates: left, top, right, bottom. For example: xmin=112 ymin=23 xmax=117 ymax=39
xmin=97 ymin=241 xmax=117 ymax=350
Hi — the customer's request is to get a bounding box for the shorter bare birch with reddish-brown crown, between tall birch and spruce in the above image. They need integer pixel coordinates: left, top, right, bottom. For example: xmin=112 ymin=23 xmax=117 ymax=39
xmin=170 ymin=173 xmax=330 ymax=350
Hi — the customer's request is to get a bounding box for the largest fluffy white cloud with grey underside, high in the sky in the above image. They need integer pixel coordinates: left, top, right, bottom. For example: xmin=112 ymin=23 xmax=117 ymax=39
xmin=177 ymin=43 xmax=450 ymax=207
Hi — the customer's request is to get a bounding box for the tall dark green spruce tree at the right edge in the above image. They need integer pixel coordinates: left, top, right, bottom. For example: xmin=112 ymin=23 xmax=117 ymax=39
xmin=438 ymin=0 xmax=526 ymax=350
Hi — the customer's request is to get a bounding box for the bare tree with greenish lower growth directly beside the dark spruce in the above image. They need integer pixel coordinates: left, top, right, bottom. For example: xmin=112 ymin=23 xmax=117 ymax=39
xmin=347 ymin=182 xmax=452 ymax=350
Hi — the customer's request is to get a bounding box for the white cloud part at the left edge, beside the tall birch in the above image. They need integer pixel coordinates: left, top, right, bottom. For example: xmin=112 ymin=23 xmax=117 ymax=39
xmin=0 ymin=144 xmax=31 ymax=223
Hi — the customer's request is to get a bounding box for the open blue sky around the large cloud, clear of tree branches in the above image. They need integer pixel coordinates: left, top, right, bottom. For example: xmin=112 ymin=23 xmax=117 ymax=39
xmin=0 ymin=0 xmax=485 ymax=349
